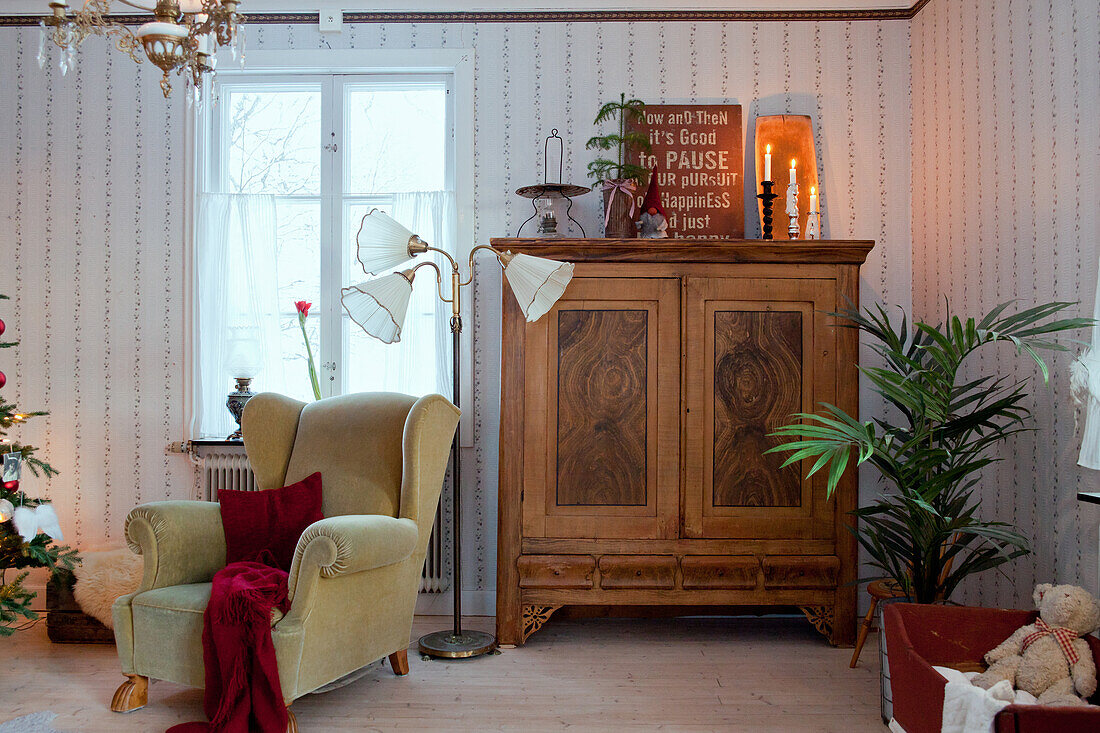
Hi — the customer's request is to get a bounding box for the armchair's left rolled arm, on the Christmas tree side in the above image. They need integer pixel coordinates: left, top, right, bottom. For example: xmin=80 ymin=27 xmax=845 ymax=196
xmin=125 ymin=501 xmax=226 ymax=592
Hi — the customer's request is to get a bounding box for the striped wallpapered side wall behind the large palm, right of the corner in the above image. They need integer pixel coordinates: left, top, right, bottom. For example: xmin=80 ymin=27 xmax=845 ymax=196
xmin=912 ymin=0 xmax=1100 ymax=605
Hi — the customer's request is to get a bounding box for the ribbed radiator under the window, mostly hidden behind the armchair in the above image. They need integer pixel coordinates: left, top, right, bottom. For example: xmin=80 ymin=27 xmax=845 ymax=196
xmin=187 ymin=442 xmax=448 ymax=593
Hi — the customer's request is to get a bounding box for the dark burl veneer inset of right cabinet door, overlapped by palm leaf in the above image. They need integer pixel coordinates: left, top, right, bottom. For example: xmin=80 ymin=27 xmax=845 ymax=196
xmin=713 ymin=310 xmax=802 ymax=506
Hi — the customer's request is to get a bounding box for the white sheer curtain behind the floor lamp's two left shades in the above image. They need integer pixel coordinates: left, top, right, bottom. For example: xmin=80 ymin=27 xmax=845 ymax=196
xmin=344 ymin=190 xmax=457 ymax=397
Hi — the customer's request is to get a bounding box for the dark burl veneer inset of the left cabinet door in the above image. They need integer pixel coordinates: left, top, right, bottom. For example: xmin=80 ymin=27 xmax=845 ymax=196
xmin=557 ymin=310 xmax=649 ymax=506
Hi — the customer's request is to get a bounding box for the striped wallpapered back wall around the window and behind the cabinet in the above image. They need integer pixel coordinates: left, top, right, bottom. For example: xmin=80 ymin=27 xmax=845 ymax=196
xmin=0 ymin=21 xmax=911 ymax=590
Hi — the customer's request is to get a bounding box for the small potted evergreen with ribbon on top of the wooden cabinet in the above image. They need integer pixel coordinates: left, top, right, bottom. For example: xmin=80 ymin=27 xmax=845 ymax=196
xmin=585 ymin=94 xmax=651 ymax=239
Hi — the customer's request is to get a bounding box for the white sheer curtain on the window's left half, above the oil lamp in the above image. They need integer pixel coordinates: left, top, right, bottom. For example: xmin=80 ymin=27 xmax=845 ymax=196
xmin=191 ymin=194 xmax=285 ymax=438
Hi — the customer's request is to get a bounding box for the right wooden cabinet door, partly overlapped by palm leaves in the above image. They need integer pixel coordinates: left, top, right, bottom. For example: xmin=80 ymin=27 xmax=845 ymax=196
xmin=684 ymin=277 xmax=836 ymax=539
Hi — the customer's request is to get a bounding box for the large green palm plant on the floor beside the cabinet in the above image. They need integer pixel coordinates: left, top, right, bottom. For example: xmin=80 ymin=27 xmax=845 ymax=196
xmin=769 ymin=303 xmax=1092 ymax=603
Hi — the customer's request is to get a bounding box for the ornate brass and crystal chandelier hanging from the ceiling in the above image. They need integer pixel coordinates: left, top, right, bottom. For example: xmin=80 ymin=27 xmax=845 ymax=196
xmin=39 ymin=0 xmax=244 ymax=101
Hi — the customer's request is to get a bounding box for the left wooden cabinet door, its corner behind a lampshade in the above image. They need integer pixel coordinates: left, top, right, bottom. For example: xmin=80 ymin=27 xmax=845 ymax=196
xmin=521 ymin=277 xmax=680 ymax=538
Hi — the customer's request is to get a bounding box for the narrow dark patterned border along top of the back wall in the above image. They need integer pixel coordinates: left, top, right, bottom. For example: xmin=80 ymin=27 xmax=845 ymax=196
xmin=0 ymin=0 xmax=930 ymax=28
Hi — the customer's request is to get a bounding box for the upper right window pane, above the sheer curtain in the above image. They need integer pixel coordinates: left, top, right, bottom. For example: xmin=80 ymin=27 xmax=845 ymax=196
xmin=344 ymin=85 xmax=448 ymax=194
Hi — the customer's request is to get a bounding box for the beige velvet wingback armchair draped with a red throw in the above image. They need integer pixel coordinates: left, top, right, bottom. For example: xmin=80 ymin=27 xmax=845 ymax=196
xmin=111 ymin=393 xmax=459 ymax=730
